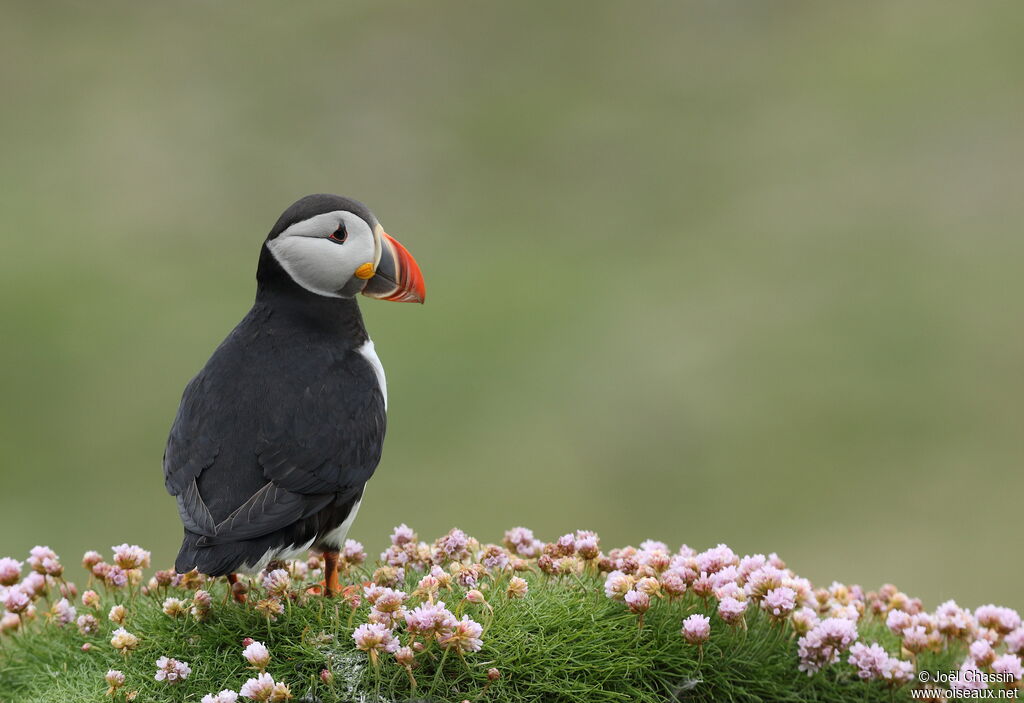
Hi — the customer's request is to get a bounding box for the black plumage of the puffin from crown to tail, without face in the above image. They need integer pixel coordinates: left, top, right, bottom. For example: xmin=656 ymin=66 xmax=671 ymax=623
xmin=164 ymin=195 xmax=386 ymax=575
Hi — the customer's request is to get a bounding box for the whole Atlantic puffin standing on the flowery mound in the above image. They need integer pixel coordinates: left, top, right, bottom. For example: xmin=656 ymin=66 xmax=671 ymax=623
xmin=164 ymin=193 xmax=425 ymax=596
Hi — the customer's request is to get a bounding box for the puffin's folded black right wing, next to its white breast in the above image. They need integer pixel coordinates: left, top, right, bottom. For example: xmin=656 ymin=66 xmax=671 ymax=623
xmin=256 ymin=351 xmax=387 ymax=495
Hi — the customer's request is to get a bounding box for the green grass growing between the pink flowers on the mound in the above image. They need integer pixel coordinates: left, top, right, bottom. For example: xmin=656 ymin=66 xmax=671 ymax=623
xmin=0 ymin=540 xmax=964 ymax=703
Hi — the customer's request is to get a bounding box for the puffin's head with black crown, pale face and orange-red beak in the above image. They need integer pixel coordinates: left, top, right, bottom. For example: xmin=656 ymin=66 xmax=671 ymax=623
xmin=260 ymin=193 xmax=426 ymax=303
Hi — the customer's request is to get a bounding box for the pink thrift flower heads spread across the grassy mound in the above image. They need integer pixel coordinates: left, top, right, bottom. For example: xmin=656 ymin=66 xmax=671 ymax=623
xmin=0 ymin=524 xmax=1024 ymax=703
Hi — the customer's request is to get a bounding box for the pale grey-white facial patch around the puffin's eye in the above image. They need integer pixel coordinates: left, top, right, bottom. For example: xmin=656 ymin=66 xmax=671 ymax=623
xmin=267 ymin=210 xmax=376 ymax=298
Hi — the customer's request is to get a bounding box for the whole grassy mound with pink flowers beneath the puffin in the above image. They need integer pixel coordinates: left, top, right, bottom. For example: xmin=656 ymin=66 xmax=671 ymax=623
xmin=0 ymin=525 xmax=1024 ymax=703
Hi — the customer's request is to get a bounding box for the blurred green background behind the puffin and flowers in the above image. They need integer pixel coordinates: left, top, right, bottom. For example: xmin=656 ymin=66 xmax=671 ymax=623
xmin=0 ymin=0 xmax=1024 ymax=608
